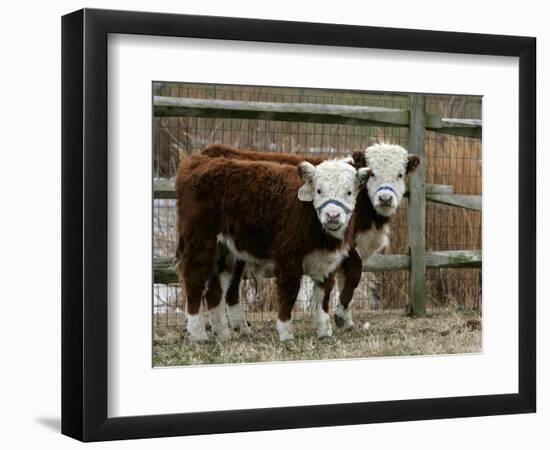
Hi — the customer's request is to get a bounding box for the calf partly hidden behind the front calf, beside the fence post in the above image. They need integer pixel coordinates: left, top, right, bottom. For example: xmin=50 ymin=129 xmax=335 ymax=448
xmin=202 ymin=143 xmax=420 ymax=334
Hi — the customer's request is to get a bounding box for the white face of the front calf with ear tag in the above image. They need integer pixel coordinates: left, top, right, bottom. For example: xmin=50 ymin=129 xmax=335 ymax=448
xmin=298 ymin=160 xmax=369 ymax=239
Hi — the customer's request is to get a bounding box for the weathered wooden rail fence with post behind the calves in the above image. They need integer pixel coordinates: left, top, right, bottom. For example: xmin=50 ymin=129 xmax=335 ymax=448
xmin=153 ymin=94 xmax=482 ymax=316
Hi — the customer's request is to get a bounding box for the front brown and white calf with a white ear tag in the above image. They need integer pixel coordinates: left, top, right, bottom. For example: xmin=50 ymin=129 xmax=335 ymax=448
xmin=176 ymin=155 xmax=368 ymax=341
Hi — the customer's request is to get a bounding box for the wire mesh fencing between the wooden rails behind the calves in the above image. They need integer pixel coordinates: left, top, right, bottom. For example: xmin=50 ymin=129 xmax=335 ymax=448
xmin=153 ymin=83 xmax=482 ymax=327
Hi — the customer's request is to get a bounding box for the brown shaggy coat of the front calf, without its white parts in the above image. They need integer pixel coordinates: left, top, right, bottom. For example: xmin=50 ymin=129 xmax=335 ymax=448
xmin=176 ymin=155 xmax=353 ymax=322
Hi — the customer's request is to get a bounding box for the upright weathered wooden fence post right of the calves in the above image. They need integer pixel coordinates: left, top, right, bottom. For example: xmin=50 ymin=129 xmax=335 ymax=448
xmin=407 ymin=94 xmax=426 ymax=317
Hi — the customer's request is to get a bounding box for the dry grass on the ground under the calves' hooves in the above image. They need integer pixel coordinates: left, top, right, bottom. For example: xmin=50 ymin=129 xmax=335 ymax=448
xmin=153 ymin=308 xmax=482 ymax=366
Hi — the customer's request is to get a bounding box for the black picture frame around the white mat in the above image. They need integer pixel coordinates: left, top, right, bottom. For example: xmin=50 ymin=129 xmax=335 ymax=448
xmin=62 ymin=9 xmax=536 ymax=441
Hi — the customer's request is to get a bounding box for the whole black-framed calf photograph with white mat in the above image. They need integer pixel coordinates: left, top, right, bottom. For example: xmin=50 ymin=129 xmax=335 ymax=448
xmin=62 ymin=9 xmax=536 ymax=441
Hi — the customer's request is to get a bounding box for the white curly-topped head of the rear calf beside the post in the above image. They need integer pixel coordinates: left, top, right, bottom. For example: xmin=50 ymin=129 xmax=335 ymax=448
xmin=360 ymin=144 xmax=420 ymax=217
